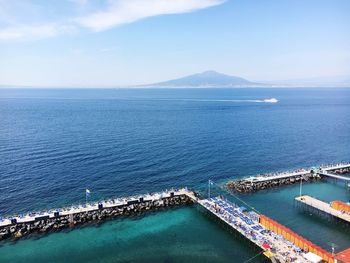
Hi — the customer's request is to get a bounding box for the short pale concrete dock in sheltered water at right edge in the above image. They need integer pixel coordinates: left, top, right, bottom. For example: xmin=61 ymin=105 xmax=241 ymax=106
xmin=295 ymin=195 xmax=350 ymax=223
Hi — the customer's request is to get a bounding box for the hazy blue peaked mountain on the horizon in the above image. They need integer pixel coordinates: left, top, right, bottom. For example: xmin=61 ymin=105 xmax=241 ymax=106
xmin=149 ymin=71 xmax=263 ymax=87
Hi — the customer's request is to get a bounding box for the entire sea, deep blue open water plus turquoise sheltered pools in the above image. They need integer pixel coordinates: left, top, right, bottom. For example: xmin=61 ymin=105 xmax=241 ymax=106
xmin=0 ymin=87 xmax=350 ymax=263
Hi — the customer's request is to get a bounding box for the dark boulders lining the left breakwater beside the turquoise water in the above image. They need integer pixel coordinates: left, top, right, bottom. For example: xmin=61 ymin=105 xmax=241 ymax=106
xmin=0 ymin=195 xmax=193 ymax=240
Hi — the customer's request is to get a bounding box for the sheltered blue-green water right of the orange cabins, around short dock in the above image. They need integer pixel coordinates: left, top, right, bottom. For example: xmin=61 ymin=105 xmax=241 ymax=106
xmin=244 ymin=180 xmax=350 ymax=251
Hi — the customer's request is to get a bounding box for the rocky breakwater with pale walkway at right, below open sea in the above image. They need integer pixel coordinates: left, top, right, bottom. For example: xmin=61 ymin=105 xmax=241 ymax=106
xmin=226 ymin=163 xmax=350 ymax=193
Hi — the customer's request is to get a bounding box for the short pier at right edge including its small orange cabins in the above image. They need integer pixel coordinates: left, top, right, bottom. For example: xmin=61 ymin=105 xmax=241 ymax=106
xmin=295 ymin=195 xmax=350 ymax=223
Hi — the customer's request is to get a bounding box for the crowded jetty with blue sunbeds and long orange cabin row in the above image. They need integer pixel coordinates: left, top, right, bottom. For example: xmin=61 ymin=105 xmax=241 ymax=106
xmin=197 ymin=197 xmax=336 ymax=263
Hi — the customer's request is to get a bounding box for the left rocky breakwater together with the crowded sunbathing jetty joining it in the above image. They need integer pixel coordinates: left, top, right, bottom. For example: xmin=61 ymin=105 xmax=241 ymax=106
xmin=0 ymin=188 xmax=346 ymax=263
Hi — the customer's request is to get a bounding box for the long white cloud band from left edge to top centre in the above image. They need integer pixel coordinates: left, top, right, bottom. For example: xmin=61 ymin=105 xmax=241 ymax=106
xmin=0 ymin=0 xmax=226 ymax=41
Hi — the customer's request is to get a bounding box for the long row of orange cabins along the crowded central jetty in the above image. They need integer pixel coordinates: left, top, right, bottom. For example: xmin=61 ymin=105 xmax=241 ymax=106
xmin=259 ymin=215 xmax=334 ymax=263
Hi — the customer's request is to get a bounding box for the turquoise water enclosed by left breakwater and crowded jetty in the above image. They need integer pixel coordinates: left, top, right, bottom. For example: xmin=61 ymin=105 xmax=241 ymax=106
xmin=0 ymin=207 xmax=266 ymax=263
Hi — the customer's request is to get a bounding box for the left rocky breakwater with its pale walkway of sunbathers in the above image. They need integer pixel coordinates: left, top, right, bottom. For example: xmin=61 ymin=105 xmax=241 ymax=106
xmin=0 ymin=188 xmax=197 ymax=240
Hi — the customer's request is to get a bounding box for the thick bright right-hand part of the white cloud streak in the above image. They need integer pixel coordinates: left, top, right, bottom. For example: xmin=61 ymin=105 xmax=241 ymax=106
xmin=76 ymin=0 xmax=224 ymax=31
